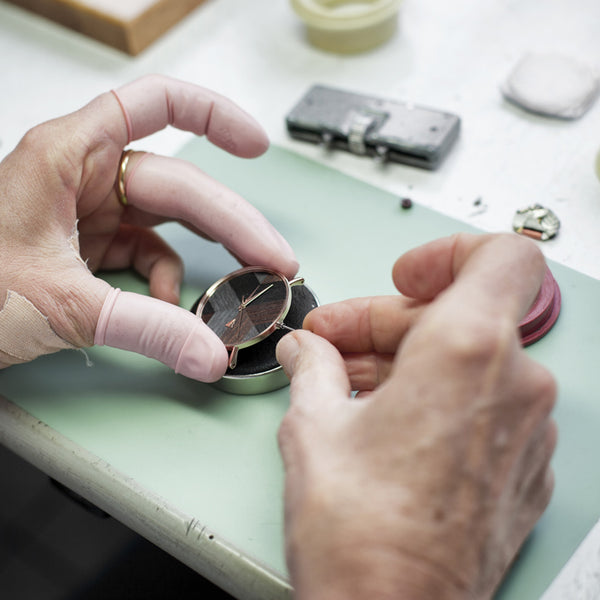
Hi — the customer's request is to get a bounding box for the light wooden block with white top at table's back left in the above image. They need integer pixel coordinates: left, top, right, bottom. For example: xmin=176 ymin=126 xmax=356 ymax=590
xmin=8 ymin=0 xmax=209 ymax=55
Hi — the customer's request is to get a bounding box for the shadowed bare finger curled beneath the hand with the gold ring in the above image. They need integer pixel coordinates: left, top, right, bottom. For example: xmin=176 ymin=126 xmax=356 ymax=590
xmin=89 ymin=225 xmax=183 ymax=304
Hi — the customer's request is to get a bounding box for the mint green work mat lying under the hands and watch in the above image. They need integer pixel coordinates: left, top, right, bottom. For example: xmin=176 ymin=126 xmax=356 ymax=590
xmin=0 ymin=140 xmax=600 ymax=599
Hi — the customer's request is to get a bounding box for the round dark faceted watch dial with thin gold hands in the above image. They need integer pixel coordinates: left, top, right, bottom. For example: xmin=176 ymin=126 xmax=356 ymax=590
xmin=199 ymin=269 xmax=290 ymax=347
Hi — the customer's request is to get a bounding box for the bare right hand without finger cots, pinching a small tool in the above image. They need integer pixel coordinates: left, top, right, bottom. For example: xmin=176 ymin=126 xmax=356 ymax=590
xmin=277 ymin=234 xmax=557 ymax=600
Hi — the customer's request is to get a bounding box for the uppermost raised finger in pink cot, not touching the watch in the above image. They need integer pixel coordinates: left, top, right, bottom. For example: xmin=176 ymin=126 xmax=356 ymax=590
xmin=113 ymin=75 xmax=269 ymax=158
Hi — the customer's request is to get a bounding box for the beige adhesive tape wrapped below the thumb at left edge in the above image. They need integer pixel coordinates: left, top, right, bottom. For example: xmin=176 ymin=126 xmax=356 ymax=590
xmin=0 ymin=290 xmax=75 ymax=365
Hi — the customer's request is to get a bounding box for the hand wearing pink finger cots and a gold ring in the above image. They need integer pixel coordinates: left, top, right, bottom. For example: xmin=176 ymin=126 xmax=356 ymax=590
xmin=0 ymin=75 xmax=298 ymax=381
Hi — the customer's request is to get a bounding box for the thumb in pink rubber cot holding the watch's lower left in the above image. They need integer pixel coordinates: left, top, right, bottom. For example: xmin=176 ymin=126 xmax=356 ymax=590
xmin=94 ymin=288 xmax=227 ymax=382
